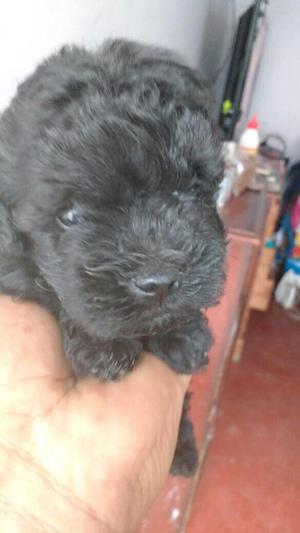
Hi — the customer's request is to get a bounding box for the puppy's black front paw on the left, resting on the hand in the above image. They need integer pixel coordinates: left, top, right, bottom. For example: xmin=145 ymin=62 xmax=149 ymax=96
xmin=62 ymin=321 xmax=142 ymax=380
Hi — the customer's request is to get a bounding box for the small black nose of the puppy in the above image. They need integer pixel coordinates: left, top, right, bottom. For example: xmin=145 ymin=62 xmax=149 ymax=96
xmin=134 ymin=274 xmax=181 ymax=298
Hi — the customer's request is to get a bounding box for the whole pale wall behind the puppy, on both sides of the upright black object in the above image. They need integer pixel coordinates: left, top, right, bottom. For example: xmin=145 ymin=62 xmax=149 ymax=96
xmin=0 ymin=0 xmax=300 ymax=159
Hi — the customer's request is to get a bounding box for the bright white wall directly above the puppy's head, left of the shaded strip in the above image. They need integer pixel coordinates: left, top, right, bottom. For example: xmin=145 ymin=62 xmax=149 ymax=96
xmin=0 ymin=0 xmax=210 ymax=110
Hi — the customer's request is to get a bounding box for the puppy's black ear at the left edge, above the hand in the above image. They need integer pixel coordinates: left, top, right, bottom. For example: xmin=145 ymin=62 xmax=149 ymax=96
xmin=0 ymin=201 xmax=37 ymax=299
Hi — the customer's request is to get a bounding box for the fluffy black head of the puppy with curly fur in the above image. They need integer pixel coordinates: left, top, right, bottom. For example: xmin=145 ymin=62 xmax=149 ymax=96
xmin=8 ymin=45 xmax=225 ymax=338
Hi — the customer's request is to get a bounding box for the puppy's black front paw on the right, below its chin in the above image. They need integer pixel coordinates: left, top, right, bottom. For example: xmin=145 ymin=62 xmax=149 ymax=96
xmin=145 ymin=312 xmax=212 ymax=374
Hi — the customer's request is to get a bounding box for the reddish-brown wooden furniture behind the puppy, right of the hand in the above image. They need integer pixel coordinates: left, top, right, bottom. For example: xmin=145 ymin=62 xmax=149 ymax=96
xmin=140 ymin=153 xmax=279 ymax=533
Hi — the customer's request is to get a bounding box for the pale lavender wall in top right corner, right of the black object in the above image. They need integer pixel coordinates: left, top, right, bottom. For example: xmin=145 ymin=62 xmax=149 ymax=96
xmin=252 ymin=0 xmax=300 ymax=160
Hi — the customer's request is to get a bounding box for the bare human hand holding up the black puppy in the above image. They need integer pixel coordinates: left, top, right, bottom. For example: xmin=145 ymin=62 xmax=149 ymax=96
xmin=0 ymin=296 xmax=189 ymax=533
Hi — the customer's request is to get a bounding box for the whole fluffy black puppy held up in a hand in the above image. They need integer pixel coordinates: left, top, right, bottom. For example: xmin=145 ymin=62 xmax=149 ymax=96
xmin=0 ymin=40 xmax=225 ymax=475
